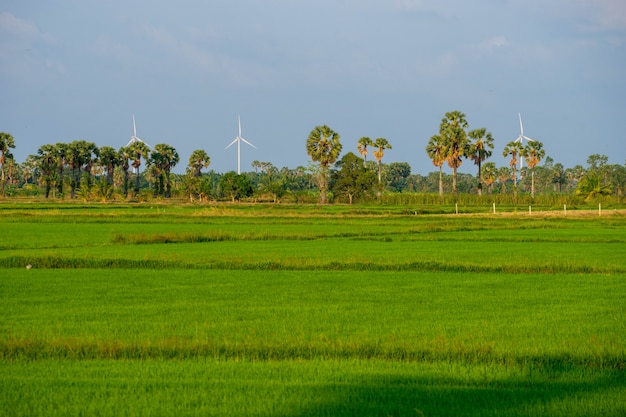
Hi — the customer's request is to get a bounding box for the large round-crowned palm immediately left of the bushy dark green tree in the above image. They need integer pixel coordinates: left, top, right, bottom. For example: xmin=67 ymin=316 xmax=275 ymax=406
xmin=306 ymin=125 xmax=342 ymax=204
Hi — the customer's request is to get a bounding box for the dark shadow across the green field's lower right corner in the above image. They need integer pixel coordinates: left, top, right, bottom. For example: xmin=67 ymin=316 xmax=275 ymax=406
xmin=285 ymin=373 xmax=626 ymax=417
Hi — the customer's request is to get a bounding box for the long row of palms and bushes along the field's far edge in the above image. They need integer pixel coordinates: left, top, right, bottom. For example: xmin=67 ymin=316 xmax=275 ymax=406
xmin=0 ymin=111 xmax=626 ymax=204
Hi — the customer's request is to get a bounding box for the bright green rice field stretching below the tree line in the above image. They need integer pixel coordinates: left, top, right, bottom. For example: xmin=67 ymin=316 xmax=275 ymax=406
xmin=0 ymin=204 xmax=626 ymax=416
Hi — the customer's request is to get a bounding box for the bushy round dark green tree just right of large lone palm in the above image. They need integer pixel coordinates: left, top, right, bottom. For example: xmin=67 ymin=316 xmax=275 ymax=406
xmin=331 ymin=152 xmax=376 ymax=204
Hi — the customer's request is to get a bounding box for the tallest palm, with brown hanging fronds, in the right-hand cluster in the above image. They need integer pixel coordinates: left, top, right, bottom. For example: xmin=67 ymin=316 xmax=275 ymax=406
xmin=439 ymin=110 xmax=469 ymax=199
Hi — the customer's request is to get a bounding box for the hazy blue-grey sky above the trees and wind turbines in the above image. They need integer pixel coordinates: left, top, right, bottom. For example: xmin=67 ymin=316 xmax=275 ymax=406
xmin=0 ymin=0 xmax=626 ymax=175
